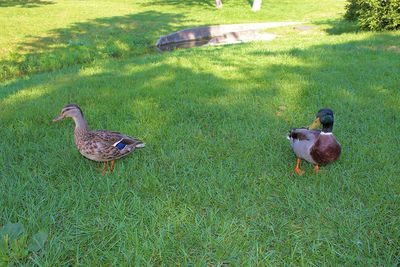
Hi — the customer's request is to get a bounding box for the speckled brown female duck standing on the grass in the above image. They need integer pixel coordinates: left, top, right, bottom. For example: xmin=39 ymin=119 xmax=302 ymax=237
xmin=53 ymin=104 xmax=146 ymax=174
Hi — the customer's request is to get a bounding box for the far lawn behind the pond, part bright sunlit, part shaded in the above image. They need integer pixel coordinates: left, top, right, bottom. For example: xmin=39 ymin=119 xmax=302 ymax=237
xmin=0 ymin=0 xmax=344 ymax=80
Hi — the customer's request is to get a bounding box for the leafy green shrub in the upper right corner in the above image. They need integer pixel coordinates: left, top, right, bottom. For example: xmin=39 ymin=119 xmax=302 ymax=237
xmin=345 ymin=0 xmax=400 ymax=31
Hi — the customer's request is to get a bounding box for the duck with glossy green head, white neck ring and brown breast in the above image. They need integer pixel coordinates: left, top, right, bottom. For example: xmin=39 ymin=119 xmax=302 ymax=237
xmin=286 ymin=108 xmax=342 ymax=174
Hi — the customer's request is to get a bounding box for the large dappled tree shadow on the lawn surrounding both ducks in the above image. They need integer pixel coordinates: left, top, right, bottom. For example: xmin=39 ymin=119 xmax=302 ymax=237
xmin=0 ymin=34 xmax=400 ymax=265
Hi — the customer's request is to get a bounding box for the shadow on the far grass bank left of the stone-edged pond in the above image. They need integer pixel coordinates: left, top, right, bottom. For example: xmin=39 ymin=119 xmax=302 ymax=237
xmin=0 ymin=11 xmax=191 ymax=80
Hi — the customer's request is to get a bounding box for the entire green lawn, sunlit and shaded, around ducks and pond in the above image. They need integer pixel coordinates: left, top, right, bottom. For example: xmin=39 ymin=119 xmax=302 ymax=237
xmin=0 ymin=0 xmax=400 ymax=266
